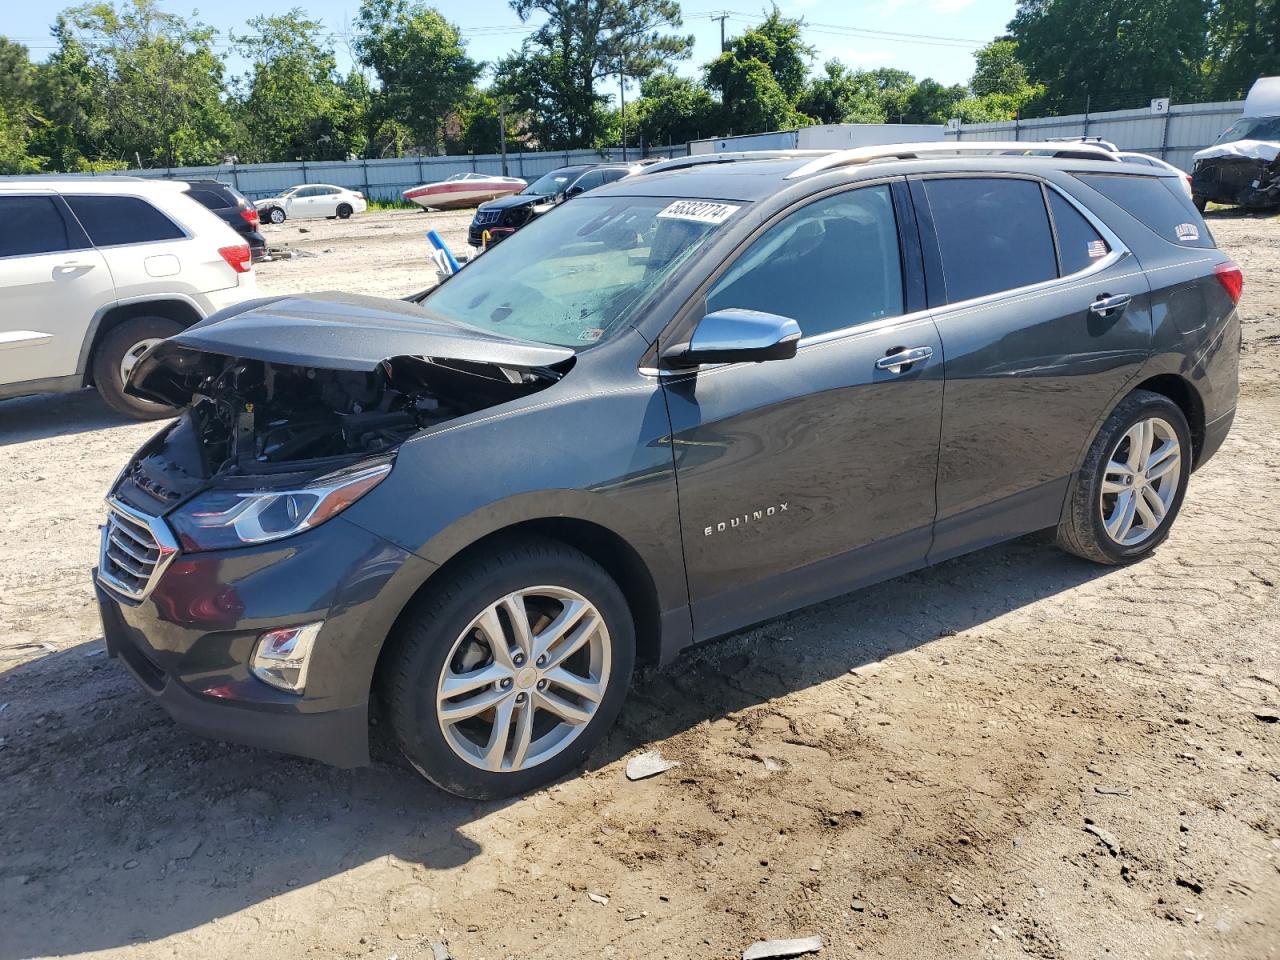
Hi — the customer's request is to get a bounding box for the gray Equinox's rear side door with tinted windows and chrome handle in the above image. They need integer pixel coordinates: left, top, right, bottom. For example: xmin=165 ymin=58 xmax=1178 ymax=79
xmin=911 ymin=175 xmax=1151 ymax=562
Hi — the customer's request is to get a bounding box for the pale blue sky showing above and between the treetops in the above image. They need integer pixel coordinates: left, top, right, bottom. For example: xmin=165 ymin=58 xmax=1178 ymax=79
xmin=0 ymin=0 xmax=1014 ymax=92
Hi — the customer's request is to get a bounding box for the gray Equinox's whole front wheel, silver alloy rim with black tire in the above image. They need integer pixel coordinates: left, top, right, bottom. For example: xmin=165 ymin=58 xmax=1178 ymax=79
xmin=385 ymin=540 xmax=635 ymax=799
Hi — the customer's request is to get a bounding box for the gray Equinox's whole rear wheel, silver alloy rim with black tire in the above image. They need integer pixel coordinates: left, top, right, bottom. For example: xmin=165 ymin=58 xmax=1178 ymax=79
xmin=1059 ymin=390 xmax=1192 ymax=563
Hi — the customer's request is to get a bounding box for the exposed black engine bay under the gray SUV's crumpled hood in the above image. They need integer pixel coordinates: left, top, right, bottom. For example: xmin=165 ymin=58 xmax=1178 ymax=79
xmin=127 ymin=351 xmax=563 ymax=507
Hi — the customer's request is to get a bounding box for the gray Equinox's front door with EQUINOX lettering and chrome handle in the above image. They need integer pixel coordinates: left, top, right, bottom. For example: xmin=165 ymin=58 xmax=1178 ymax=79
xmin=664 ymin=183 xmax=943 ymax=639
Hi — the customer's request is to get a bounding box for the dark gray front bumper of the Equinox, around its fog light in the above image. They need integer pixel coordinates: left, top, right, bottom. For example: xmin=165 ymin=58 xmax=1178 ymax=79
xmin=95 ymin=517 xmax=431 ymax=767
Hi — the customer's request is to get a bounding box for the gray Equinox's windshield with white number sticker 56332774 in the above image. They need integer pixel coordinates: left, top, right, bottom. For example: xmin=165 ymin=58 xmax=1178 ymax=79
xmin=422 ymin=196 xmax=742 ymax=347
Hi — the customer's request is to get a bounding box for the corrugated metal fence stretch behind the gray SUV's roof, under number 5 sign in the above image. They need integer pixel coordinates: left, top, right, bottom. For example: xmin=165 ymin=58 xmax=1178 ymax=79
xmin=946 ymin=100 xmax=1244 ymax=173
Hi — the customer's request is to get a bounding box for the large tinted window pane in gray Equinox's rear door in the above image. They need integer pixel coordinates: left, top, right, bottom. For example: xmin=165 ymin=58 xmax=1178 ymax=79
xmin=924 ymin=177 xmax=1057 ymax=303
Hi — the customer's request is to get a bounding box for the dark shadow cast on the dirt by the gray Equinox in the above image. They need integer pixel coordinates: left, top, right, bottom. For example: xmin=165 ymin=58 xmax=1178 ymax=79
xmin=0 ymin=536 xmax=1108 ymax=960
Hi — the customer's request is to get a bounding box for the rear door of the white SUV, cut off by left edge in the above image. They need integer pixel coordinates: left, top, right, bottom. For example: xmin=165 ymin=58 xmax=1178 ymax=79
xmin=0 ymin=192 xmax=115 ymax=387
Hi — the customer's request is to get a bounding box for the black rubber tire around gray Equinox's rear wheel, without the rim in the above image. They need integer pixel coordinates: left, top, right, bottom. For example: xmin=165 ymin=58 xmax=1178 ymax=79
xmin=1057 ymin=390 xmax=1192 ymax=566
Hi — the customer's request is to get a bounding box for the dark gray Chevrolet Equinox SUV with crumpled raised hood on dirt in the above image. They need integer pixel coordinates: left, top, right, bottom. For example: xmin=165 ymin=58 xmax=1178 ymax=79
xmin=96 ymin=145 xmax=1242 ymax=796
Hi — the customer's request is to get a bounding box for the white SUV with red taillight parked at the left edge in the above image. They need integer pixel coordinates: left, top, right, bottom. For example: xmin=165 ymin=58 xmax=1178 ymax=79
xmin=0 ymin=177 xmax=256 ymax=420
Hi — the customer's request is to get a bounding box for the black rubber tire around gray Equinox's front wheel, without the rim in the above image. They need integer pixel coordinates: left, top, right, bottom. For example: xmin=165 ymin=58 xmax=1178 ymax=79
xmin=380 ymin=538 xmax=635 ymax=800
